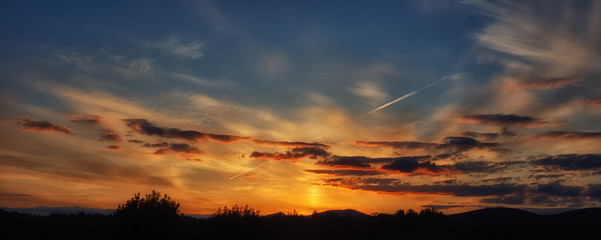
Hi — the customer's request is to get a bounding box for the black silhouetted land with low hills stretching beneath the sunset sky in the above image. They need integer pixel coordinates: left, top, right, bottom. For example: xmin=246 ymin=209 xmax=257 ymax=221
xmin=0 ymin=208 xmax=601 ymax=239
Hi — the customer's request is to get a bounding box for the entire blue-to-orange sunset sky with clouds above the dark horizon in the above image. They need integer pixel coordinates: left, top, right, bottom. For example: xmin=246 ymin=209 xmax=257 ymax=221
xmin=0 ymin=0 xmax=601 ymax=214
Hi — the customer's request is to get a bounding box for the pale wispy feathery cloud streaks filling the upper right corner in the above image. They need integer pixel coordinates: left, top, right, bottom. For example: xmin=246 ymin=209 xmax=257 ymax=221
xmin=466 ymin=1 xmax=601 ymax=77
